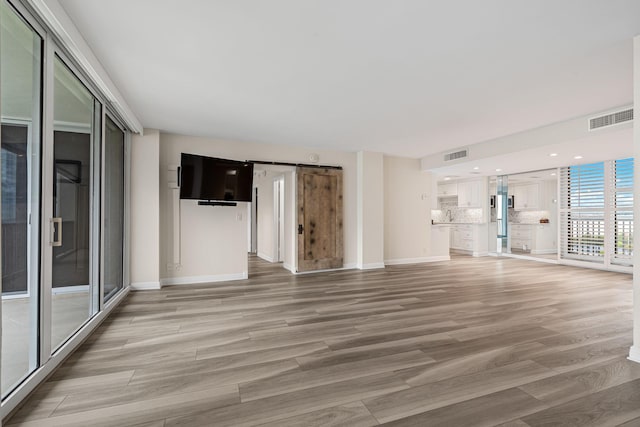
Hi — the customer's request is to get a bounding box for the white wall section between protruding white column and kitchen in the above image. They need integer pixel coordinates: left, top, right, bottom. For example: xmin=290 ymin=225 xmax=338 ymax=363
xmin=384 ymin=156 xmax=432 ymax=264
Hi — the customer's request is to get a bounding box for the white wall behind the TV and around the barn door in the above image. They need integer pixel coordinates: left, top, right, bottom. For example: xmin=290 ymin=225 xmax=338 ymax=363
xmin=159 ymin=133 xmax=357 ymax=284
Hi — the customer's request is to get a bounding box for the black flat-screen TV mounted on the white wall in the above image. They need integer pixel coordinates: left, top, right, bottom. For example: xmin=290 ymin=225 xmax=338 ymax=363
xmin=180 ymin=153 xmax=253 ymax=202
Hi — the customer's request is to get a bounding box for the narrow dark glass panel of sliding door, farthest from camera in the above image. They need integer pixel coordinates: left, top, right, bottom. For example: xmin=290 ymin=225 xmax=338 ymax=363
xmin=102 ymin=117 xmax=124 ymax=302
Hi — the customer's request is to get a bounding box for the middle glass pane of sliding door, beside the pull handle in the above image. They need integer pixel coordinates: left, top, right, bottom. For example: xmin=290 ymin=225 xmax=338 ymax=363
xmin=50 ymin=57 xmax=100 ymax=351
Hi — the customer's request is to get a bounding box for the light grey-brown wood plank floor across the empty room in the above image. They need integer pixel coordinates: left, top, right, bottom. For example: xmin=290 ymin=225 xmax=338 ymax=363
xmin=8 ymin=256 xmax=640 ymax=427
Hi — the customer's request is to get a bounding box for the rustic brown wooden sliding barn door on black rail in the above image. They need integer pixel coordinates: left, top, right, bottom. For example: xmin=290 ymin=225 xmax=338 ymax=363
xmin=296 ymin=167 xmax=343 ymax=272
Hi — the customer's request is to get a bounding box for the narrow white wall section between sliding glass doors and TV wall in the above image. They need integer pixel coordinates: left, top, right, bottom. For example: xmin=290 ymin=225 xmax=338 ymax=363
xmin=131 ymin=129 xmax=160 ymax=289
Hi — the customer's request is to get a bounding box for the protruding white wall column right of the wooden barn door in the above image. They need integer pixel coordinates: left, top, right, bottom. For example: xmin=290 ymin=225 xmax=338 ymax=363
xmin=357 ymin=151 xmax=384 ymax=269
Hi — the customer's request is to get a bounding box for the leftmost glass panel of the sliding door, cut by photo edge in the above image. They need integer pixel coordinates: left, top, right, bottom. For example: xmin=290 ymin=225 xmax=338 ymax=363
xmin=0 ymin=1 xmax=42 ymax=398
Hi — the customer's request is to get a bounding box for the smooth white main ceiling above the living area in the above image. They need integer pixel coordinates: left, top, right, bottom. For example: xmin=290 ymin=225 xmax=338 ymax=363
xmin=60 ymin=0 xmax=640 ymax=158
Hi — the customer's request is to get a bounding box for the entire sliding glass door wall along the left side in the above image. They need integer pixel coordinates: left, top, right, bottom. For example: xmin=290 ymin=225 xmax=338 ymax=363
xmin=0 ymin=0 xmax=127 ymax=404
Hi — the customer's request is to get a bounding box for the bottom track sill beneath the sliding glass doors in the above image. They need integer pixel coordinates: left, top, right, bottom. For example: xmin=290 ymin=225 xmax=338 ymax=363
xmin=0 ymin=287 xmax=129 ymax=419
